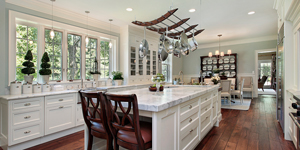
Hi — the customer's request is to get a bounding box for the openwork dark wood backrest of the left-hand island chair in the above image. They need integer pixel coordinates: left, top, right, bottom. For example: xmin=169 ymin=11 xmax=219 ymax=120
xmin=79 ymin=90 xmax=109 ymax=132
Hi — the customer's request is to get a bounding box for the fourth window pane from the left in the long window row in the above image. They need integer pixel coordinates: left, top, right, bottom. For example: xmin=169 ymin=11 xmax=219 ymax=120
xmin=85 ymin=38 xmax=97 ymax=79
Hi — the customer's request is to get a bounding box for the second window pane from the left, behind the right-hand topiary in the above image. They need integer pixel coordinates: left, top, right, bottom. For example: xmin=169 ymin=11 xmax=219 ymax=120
xmin=45 ymin=29 xmax=62 ymax=80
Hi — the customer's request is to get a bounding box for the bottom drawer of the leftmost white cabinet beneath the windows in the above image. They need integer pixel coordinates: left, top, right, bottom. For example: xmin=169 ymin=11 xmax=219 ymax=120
xmin=11 ymin=124 xmax=43 ymax=145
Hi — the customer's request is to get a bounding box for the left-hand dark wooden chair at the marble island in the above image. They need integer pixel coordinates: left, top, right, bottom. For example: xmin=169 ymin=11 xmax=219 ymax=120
xmin=79 ymin=91 xmax=113 ymax=150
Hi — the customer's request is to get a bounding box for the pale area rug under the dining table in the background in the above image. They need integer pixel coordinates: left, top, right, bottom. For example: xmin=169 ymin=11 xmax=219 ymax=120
xmin=221 ymin=98 xmax=251 ymax=110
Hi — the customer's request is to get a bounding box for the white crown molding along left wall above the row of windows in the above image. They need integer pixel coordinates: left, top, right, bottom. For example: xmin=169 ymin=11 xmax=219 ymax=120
xmin=6 ymin=0 xmax=120 ymax=33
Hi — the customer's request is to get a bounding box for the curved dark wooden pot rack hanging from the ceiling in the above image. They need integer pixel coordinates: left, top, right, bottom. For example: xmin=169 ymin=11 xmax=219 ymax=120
xmin=132 ymin=8 xmax=204 ymax=39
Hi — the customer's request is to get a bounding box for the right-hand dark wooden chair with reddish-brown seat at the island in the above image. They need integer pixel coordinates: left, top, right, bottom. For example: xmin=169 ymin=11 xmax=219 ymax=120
xmin=104 ymin=93 xmax=152 ymax=150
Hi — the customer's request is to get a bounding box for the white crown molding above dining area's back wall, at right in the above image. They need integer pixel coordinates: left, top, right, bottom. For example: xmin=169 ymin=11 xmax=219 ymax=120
xmin=198 ymin=35 xmax=277 ymax=49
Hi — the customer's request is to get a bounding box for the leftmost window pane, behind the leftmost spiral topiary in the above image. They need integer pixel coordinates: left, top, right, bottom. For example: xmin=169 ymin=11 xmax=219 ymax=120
xmin=16 ymin=24 xmax=37 ymax=81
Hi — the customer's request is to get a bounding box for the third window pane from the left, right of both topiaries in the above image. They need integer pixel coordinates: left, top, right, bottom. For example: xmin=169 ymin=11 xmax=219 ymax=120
xmin=67 ymin=34 xmax=81 ymax=80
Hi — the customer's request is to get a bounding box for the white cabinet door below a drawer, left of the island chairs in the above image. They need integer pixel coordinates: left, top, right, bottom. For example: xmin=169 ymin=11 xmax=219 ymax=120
xmin=45 ymin=104 xmax=75 ymax=135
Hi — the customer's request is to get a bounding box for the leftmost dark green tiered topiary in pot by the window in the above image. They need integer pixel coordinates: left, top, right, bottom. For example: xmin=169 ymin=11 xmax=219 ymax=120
xmin=21 ymin=50 xmax=35 ymax=83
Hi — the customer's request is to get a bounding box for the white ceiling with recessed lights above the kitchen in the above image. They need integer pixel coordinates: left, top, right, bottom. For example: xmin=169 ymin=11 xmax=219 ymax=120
xmin=38 ymin=0 xmax=277 ymax=44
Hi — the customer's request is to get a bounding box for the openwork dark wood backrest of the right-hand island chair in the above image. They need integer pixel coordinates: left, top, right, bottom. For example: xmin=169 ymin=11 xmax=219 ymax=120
xmin=104 ymin=93 xmax=144 ymax=147
